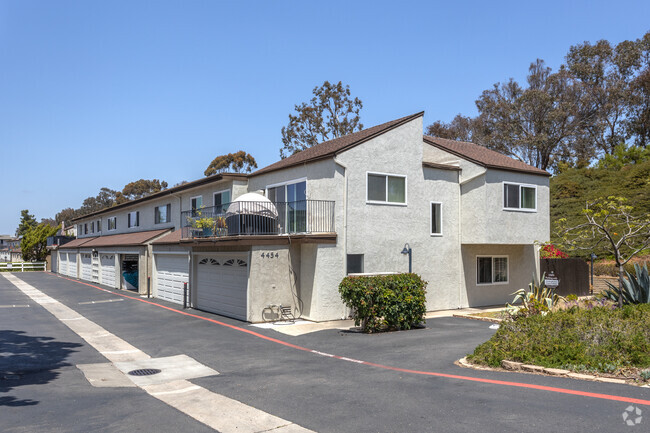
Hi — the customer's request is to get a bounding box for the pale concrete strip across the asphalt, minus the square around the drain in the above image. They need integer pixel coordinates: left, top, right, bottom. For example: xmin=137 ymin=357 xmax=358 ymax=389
xmin=0 ymin=273 xmax=313 ymax=433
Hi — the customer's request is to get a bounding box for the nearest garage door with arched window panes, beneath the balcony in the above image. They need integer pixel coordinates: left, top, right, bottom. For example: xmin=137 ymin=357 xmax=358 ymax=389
xmin=195 ymin=254 xmax=248 ymax=320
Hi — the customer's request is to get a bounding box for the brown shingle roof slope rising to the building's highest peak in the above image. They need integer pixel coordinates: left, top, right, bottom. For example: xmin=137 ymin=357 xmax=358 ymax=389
xmin=250 ymin=111 xmax=424 ymax=176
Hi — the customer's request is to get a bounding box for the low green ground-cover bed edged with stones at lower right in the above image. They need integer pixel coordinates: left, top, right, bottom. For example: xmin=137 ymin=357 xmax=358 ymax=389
xmin=469 ymin=304 xmax=650 ymax=373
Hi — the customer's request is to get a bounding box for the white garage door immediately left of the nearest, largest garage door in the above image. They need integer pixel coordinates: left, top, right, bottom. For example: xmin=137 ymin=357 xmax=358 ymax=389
xmin=155 ymin=254 xmax=189 ymax=304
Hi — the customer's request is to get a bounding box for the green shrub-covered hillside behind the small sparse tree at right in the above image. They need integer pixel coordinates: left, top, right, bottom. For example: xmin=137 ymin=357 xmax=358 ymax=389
xmin=551 ymin=161 xmax=650 ymax=257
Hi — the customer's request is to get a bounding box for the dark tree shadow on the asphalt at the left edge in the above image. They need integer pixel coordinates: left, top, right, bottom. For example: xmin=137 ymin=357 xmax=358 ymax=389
xmin=0 ymin=330 xmax=81 ymax=406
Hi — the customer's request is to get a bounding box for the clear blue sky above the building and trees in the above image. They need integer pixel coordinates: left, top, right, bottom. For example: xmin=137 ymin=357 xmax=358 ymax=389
xmin=0 ymin=0 xmax=650 ymax=234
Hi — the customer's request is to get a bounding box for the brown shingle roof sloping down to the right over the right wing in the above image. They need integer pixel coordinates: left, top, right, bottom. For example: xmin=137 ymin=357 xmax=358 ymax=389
xmin=424 ymin=135 xmax=551 ymax=176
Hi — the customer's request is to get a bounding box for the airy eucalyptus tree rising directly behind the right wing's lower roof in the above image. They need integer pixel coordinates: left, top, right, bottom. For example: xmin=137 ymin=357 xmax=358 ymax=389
xmin=476 ymin=59 xmax=593 ymax=170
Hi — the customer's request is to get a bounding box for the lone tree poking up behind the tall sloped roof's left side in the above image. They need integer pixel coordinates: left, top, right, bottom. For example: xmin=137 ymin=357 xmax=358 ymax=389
xmin=280 ymin=81 xmax=363 ymax=159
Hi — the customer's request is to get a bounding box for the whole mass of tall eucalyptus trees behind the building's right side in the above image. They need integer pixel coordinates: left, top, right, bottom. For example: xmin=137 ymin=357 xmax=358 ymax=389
xmin=426 ymin=32 xmax=650 ymax=172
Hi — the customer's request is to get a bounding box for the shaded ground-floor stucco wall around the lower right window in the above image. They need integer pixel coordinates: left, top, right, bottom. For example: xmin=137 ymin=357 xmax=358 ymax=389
xmin=462 ymin=245 xmax=537 ymax=307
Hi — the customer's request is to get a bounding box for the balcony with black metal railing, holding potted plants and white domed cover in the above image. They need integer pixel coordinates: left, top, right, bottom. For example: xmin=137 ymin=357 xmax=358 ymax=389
xmin=181 ymin=200 xmax=334 ymax=239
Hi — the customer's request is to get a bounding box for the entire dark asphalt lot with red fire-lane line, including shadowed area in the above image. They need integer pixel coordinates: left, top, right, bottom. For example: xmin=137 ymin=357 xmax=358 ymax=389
xmin=0 ymin=273 xmax=650 ymax=432
